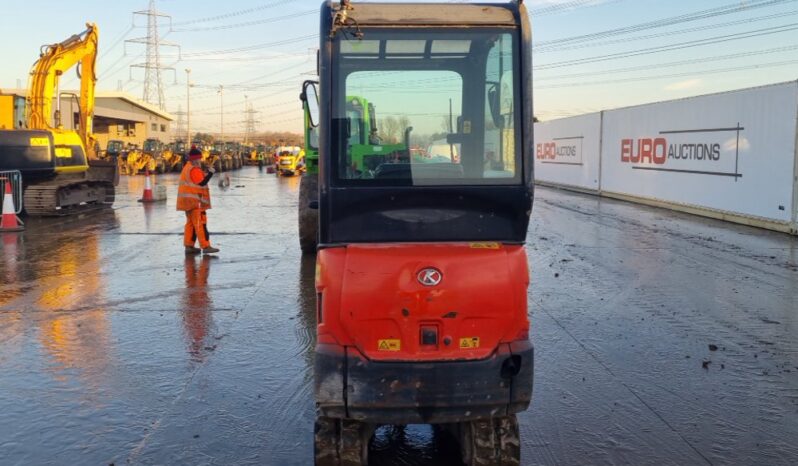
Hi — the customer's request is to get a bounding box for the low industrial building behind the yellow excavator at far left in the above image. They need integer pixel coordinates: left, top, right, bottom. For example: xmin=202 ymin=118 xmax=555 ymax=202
xmin=0 ymin=89 xmax=174 ymax=148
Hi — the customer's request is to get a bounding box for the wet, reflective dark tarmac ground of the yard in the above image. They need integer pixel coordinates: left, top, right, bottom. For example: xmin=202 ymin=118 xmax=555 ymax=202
xmin=0 ymin=168 xmax=798 ymax=466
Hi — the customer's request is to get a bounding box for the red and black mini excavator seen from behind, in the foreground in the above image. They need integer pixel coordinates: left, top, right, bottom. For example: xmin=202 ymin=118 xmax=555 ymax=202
xmin=314 ymin=2 xmax=533 ymax=466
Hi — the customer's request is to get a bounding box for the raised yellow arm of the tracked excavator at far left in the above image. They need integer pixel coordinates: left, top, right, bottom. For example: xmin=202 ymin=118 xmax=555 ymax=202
xmin=26 ymin=23 xmax=99 ymax=157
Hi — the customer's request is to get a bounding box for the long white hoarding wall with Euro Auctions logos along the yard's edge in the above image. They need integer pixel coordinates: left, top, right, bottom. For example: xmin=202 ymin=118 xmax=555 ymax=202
xmin=535 ymin=82 xmax=798 ymax=232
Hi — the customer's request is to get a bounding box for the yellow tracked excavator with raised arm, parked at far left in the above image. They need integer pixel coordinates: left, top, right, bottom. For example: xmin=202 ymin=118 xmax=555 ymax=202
xmin=0 ymin=24 xmax=119 ymax=216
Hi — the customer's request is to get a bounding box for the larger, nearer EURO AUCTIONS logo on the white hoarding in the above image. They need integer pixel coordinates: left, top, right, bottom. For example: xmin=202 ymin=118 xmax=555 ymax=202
xmin=619 ymin=123 xmax=747 ymax=180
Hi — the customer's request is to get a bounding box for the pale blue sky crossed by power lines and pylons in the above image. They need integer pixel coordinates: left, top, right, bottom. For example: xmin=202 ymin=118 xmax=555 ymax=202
xmin=0 ymin=0 xmax=798 ymax=135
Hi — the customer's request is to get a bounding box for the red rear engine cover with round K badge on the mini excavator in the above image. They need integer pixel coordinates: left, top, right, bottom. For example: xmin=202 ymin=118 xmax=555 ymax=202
xmin=316 ymin=243 xmax=529 ymax=361
